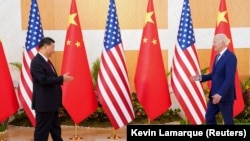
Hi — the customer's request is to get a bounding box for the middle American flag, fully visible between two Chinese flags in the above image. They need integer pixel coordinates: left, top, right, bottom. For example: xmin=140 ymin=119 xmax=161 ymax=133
xmin=97 ymin=0 xmax=134 ymax=129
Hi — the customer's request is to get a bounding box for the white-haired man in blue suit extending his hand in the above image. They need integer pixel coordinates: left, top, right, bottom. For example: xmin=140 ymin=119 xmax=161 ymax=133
xmin=191 ymin=34 xmax=237 ymax=125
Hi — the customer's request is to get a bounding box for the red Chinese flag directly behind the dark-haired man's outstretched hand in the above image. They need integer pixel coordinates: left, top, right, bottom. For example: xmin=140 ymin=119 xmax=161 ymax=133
xmin=62 ymin=0 xmax=97 ymax=124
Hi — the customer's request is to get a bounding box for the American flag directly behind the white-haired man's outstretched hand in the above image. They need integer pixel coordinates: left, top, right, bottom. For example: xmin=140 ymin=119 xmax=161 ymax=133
xmin=171 ymin=0 xmax=206 ymax=124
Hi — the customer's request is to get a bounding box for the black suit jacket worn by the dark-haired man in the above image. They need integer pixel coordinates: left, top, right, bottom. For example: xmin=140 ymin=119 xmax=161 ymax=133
xmin=30 ymin=53 xmax=63 ymax=112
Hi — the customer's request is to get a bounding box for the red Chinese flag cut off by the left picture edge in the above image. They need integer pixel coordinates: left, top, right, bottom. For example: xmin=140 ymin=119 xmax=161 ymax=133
xmin=0 ymin=40 xmax=19 ymax=123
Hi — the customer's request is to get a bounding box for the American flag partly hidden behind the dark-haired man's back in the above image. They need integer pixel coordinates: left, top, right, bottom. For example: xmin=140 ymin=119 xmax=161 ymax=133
xmin=18 ymin=0 xmax=43 ymax=126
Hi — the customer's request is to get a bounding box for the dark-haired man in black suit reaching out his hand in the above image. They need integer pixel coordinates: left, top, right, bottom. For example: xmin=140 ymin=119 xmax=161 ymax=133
xmin=30 ymin=37 xmax=73 ymax=141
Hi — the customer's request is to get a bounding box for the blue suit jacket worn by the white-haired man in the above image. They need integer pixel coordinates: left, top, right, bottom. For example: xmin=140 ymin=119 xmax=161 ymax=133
xmin=201 ymin=49 xmax=237 ymax=101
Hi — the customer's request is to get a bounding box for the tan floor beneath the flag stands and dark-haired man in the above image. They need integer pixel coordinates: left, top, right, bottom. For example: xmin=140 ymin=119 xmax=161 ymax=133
xmin=0 ymin=126 xmax=126 ymax=141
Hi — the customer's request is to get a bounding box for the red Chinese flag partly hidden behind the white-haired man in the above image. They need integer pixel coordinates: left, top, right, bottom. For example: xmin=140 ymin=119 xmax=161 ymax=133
xmin=210 ymin=0 xmax=244 ymax=117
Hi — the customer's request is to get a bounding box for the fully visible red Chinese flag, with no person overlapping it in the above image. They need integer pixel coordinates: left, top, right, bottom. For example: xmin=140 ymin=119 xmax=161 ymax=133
xmin=134 ymin=0 xmax=171 ymax=120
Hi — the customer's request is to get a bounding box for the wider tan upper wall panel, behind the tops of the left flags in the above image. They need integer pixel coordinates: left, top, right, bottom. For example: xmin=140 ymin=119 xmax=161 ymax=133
xmin=21 ymin=0 xmax=168 ymax=30
